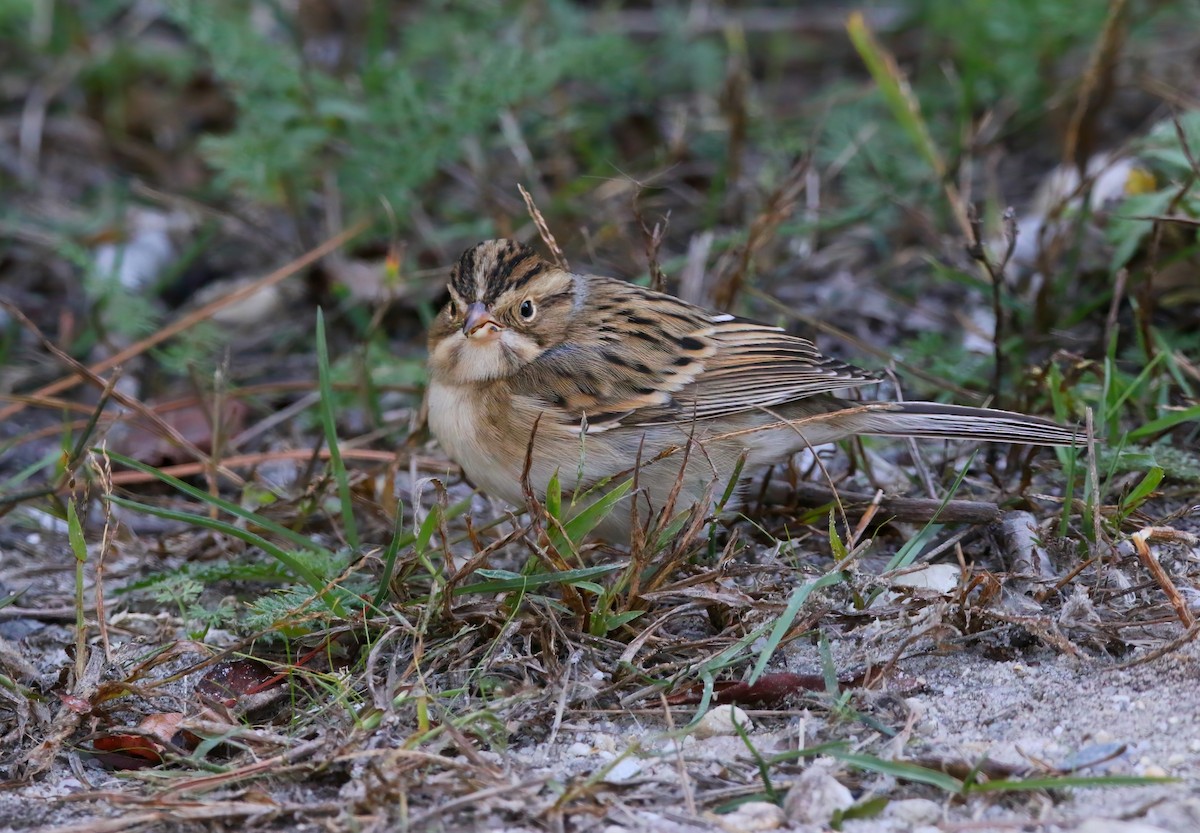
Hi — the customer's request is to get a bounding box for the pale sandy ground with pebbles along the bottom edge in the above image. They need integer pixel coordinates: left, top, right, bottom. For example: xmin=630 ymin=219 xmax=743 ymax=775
xmin=0 ymin=580 xmax=1200 ymax=833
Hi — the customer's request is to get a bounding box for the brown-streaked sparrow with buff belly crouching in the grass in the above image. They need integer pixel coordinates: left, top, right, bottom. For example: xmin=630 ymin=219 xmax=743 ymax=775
xmin=427 ymin=240 xmax=1078 ymax=543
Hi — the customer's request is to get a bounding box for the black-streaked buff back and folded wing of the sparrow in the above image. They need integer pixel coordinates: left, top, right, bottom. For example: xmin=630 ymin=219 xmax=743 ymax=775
xmin=514 ymin=277 xmax=876 ymax=432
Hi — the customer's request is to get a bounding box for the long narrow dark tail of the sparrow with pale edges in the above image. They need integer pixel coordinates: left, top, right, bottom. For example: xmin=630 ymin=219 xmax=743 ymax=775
xmin=853 ymin=402 xmax=1084 ymax=445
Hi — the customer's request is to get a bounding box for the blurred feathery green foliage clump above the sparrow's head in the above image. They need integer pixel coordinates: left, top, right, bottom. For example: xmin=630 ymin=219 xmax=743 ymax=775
xmin=169 ymin=0 xmax=713 ymax=231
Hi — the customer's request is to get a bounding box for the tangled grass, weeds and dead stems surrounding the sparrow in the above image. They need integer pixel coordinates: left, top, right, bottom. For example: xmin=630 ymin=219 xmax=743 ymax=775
xmin=0 ymin=0 xmax=1200 ymax=831
